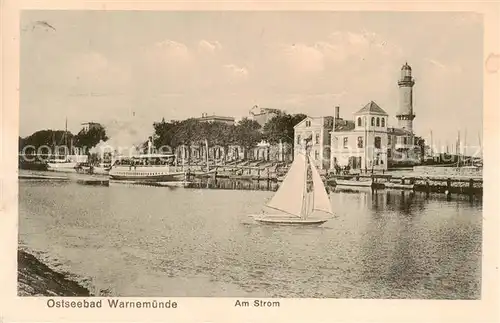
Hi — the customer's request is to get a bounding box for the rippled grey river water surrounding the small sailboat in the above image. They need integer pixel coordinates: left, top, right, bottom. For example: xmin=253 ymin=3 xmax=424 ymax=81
xmin=19 ymin=181 xmax=482 ymax=299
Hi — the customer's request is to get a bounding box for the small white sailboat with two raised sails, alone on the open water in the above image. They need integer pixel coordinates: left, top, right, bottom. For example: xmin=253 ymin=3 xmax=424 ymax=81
xmin=252 ymin=149 xmax=333 ymax=225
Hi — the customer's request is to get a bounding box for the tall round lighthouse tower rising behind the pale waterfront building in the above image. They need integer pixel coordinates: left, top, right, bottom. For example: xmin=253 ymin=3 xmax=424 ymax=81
xmin=396 ymin=63 xmax=415 ymax=133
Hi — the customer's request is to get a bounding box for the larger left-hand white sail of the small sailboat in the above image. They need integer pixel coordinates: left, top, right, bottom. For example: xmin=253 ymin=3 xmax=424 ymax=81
xmin=267 ymin=154 xmax=307 ymax=217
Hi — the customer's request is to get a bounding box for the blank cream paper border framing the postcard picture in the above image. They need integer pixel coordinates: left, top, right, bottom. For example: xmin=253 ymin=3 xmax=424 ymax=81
xmin=0 ymin=0 xmax=500 ymax=322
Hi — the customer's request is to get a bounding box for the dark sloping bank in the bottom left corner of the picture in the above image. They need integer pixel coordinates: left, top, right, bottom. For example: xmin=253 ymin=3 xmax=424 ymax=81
xmin=17 ymin=249 xmax=94 ymax=297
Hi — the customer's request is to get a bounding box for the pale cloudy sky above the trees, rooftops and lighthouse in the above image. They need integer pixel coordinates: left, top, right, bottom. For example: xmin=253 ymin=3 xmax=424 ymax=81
xmin=20 ymin=10 xmax=483 ymax=152
